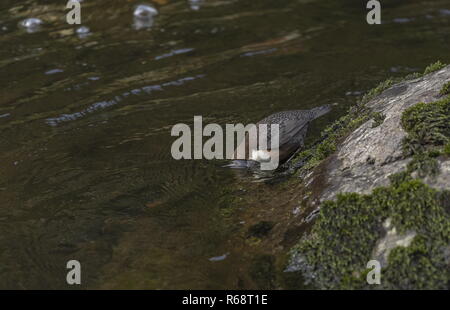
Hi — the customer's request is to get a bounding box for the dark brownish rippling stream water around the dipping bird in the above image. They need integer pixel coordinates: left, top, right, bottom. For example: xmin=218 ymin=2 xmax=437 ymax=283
xmin=0 ymin=0 xmax=450 ymax=289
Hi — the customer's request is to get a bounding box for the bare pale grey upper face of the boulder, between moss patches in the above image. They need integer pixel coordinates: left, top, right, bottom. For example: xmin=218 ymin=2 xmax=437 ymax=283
xmin=320 ymin=66 xmax=450 ymax=201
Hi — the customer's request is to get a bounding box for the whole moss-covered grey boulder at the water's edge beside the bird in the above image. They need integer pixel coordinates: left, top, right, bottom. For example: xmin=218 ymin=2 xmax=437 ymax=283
xmin=285 ymin=62 xmax=450 ymax=289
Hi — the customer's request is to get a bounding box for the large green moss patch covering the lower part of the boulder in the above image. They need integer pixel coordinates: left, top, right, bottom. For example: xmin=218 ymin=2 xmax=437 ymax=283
xmin=293 ymin=176 xmax=450 ymax=289
